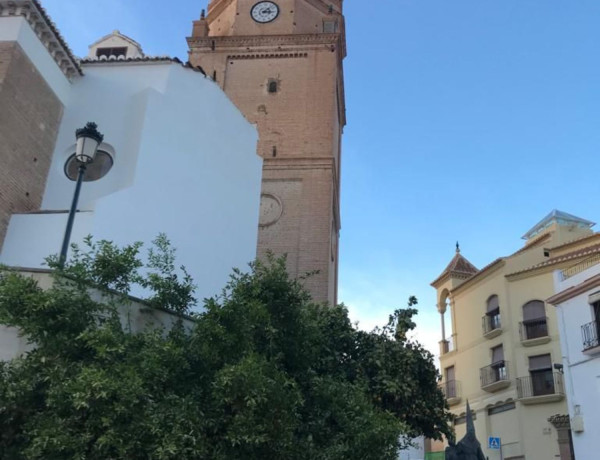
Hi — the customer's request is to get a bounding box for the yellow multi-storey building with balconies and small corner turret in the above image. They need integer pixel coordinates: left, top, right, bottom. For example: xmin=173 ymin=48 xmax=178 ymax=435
xmin=432 ymin=210 xmax=600 ymax=460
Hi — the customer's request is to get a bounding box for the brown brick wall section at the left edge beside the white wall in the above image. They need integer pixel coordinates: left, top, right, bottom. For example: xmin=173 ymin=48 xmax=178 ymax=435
xmin=0 ymin=42 xmax=63 ymax=249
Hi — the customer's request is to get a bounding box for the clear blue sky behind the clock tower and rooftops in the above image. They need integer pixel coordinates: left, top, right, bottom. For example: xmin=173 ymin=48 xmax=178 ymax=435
xmin=42 ymin=0 xmax=600 ymax=351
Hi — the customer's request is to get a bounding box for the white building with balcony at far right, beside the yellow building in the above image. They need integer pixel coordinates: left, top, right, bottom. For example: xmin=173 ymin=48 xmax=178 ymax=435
xmin=547 ymin=254 xmax=600 ymax=459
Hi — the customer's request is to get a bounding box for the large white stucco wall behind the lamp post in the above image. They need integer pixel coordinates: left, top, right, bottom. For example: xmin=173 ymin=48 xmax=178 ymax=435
xmin=0 ymin=62 xmax=262 ymax=299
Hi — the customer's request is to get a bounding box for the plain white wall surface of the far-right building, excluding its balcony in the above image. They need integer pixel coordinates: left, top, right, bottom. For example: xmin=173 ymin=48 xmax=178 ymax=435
xmin=554 ymin=265 xmax=600 ymax=459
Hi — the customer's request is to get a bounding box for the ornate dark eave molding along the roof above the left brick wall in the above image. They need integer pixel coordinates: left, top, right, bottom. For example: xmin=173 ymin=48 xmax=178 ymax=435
xmin=0 ymin=0 xmax=83 ymax=80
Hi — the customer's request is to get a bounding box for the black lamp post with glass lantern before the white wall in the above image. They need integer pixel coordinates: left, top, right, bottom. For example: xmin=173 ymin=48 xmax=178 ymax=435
xmin=58 ymin=122 xmax=104 ymax=268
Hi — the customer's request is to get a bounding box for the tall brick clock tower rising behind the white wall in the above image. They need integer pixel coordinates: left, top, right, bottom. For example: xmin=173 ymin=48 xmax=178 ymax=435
xmin=188 ymin=0 xmax=346 ymax=303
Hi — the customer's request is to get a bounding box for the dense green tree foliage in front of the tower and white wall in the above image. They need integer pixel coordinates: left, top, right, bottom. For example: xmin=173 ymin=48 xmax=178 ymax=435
xmin=0 ymin=237 xmax=451 ymax=460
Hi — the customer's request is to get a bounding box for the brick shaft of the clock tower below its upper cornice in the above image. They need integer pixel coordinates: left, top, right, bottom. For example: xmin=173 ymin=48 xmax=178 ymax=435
xmin=190 ymin=44 xmax=340 ymax=302
